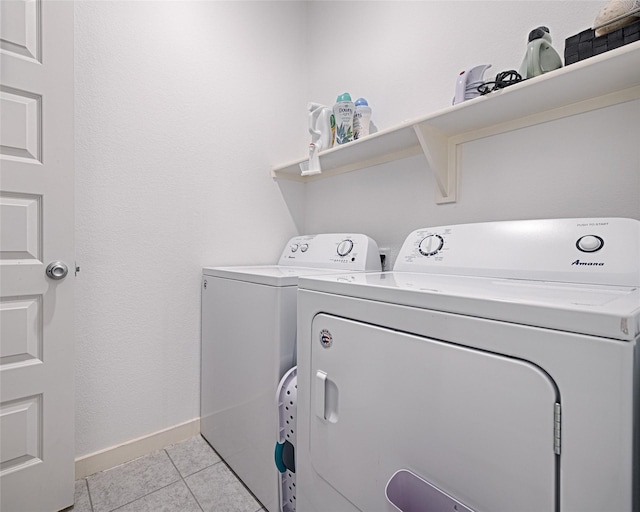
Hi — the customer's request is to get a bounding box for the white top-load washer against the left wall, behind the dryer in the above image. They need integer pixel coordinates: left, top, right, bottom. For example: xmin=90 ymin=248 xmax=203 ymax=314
xmin=200 ymin=233 xmax=380 ymax=512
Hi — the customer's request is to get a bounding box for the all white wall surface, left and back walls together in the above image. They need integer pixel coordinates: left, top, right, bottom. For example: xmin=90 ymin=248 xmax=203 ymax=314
xmin=76 ymin=0 xmax=640 ymax=456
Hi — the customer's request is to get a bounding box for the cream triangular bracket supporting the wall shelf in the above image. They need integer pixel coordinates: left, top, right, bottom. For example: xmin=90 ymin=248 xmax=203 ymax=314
xmin=413 ymin=123 xmax=459 ymax=204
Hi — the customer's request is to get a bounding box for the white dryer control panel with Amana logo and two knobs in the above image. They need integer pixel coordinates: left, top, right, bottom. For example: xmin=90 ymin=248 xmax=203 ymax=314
xmin=393 ymin=218 xmax=640 ymax=286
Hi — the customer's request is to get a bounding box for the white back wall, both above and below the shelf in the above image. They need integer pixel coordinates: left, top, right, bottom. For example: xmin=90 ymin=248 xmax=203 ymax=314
xmin=298 ymin=1 xmax=640 ymax=262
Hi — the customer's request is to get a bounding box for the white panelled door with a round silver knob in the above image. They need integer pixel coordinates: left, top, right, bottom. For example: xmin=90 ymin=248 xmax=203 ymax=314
xmin=0 ymin=0 xmax=74 ymax=512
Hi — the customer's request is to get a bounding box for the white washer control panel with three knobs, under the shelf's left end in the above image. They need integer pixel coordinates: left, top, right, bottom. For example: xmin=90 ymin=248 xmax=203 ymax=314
xmin=278 ymin=233 xmax=381 ymax=271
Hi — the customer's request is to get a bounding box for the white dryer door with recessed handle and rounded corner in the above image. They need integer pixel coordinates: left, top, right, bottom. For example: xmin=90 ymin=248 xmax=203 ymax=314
xmin=309 ymin=314 xmax=559 ymax=512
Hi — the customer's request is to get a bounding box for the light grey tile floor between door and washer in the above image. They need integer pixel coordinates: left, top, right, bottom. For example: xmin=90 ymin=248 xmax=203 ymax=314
xmin=65 ymin=436 xmax=265 ymax=512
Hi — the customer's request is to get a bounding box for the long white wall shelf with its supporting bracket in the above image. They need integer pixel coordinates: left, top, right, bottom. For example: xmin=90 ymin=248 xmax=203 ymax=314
xmin=271 ymin=42 xmax=640 ymax=203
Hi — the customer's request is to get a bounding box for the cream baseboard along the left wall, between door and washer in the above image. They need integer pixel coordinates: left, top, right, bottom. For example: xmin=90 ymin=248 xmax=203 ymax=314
xmin=76 ymin=418 xmax=200 ymax=480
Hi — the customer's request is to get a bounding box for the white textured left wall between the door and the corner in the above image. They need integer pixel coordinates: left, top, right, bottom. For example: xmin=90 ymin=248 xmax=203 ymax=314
xmin=75 ymin=1 xmax=307 ymax=456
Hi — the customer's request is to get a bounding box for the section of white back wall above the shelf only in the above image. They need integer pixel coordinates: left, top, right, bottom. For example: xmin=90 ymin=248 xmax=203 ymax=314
xmin=309 ymin=0 xmax=606 ymax=129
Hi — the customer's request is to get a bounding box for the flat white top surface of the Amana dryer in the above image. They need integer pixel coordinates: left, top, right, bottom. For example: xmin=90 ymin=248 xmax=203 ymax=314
xmin=299 ymin=272 xmax=640 ymax=340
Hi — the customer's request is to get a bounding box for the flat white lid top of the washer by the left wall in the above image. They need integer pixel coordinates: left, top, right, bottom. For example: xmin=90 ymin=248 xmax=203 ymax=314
xmin=202 ymin=265 xmax=364 ymax=286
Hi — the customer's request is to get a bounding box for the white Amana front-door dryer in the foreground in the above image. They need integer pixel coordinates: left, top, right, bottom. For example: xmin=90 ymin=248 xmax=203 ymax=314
xmin=296 ymin=219 xmax=640 ymax=512
